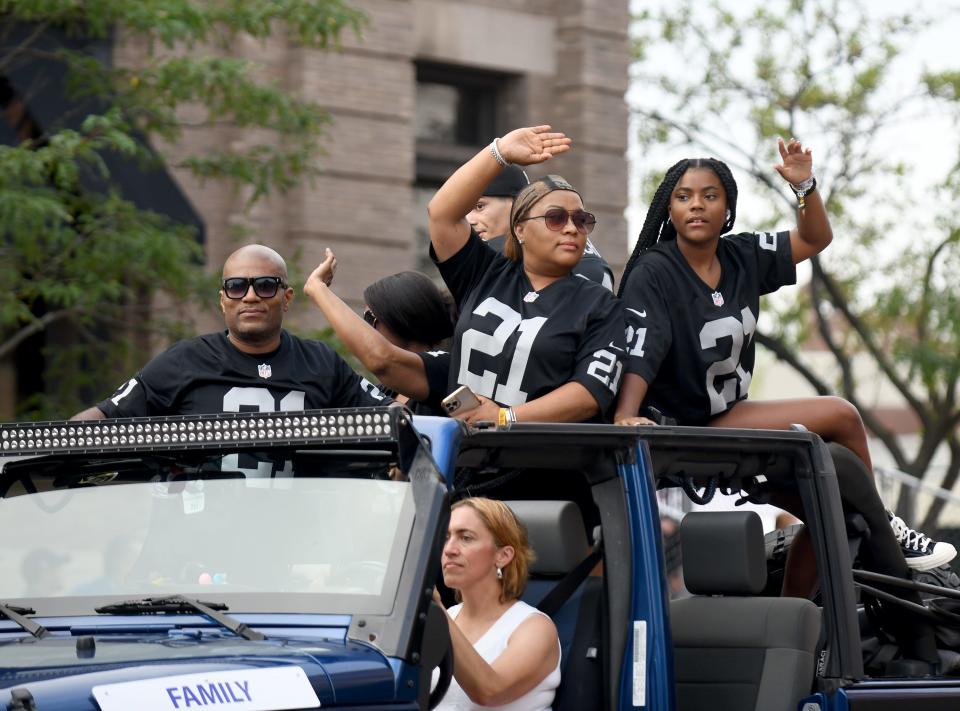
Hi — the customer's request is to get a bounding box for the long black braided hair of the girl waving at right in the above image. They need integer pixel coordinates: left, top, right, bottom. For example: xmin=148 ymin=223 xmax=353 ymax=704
xmin=617 ymin=158 xmax=737 ymax=296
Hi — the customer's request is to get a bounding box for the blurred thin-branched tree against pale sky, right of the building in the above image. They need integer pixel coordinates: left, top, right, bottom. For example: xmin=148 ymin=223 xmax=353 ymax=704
xmin=632 ymin=0 xmax=960 ymax=525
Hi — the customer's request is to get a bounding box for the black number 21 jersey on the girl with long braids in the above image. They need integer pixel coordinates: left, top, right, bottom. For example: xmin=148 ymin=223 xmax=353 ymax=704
xmin=622 ymin=232 xmax=796 ymax=425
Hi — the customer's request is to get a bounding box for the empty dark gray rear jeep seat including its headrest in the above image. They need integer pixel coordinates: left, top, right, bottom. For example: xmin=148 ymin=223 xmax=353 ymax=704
xmin=670 ymin=511 xmax=820 ymax=711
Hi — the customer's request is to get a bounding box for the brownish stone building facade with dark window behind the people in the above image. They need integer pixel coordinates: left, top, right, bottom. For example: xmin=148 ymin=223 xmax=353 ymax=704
xmin=174 ymin=0 xmax=629 ymax=330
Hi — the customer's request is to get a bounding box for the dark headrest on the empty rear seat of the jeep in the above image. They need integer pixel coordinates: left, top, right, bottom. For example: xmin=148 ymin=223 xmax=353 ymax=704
xmin=680 ymin=511 xmax=767 ymax=595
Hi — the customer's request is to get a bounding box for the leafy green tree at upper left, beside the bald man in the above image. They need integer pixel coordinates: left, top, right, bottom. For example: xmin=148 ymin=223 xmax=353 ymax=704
xmin=0 ymin=0 xmax=365 ymax=417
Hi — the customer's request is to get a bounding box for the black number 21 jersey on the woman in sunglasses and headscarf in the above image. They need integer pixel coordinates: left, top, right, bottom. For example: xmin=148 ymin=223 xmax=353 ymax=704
xmin=431 ymin=230 xmax=624 ymax=415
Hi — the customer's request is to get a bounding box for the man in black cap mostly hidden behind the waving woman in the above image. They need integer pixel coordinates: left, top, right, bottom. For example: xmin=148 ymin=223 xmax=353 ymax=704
xmin=467 ymin=165 xmax=613 ymax=291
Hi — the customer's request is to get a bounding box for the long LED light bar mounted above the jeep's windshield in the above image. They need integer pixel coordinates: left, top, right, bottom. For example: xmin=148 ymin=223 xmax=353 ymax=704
xmin=0 ymin=407 xmax=398 ymax=456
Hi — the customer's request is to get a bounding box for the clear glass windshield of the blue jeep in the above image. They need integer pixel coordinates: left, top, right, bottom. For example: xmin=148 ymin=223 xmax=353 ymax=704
xmin=0 ymin=447 xmax=415 ymax=615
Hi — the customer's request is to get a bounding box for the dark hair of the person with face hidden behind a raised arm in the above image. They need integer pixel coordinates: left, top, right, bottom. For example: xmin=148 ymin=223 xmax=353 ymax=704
xmin=363 ymin=272 xmax=454 ymax=347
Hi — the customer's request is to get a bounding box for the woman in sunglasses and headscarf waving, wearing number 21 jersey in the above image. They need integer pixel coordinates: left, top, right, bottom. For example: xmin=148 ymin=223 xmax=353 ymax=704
xmin=427 ymin=126 xmax=624 ymax=426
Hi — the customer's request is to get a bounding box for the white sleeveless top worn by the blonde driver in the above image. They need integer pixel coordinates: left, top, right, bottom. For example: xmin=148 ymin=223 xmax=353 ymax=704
xmin=434 ymin=600 xmax=560 ymax=711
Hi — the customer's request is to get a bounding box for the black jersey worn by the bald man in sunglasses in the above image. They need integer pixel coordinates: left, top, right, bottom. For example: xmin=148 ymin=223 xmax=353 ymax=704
xmin=97 ymin=331 xmax=390 ymax=417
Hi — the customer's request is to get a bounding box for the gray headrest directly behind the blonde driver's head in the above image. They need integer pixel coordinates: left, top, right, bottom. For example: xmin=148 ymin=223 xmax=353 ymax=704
xmin=504 ymin=501 xmax=590 ymax=575
